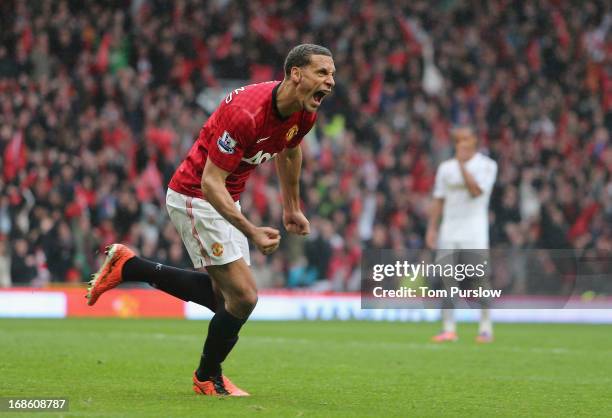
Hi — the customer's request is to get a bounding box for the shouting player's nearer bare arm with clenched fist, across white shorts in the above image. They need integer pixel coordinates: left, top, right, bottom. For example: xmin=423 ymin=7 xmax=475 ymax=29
xmin=201 ymin=159 xmax=280 ymax=254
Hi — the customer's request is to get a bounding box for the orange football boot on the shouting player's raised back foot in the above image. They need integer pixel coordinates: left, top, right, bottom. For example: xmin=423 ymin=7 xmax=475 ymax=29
xmin=86 ymin=244 xmax=136 ymax=306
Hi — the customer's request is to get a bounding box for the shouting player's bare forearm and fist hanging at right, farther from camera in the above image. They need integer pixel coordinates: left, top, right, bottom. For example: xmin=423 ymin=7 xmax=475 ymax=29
xmin=275 ymin=145 xmax=310 ymax=235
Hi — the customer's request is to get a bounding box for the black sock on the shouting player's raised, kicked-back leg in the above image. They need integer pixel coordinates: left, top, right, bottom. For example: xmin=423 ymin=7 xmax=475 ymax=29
xmin=121 ymin=257 xmax=217 ymax=312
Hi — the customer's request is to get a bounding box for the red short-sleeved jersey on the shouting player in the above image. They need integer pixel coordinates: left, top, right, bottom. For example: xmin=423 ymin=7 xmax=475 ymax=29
xmin=169 ymin=81 xmax=317 ymax=200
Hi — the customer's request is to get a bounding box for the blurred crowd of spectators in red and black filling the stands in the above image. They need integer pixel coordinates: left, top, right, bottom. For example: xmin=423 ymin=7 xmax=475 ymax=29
xmin=0 ymin=0 xmax=612 ymax=290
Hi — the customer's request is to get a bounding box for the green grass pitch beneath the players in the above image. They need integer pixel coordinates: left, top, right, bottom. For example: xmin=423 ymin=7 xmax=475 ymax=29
xmin=0 ymin=319 xmax=612 ymax=418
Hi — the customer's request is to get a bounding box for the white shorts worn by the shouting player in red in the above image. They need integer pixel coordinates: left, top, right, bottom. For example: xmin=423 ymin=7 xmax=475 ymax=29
xmin=166 ymin=188 xmax=251 ymax=268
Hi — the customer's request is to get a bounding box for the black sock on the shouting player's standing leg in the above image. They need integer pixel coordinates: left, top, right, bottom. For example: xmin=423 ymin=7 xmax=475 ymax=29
xmin=196 ymin=308 xmax=246 ymax=382
